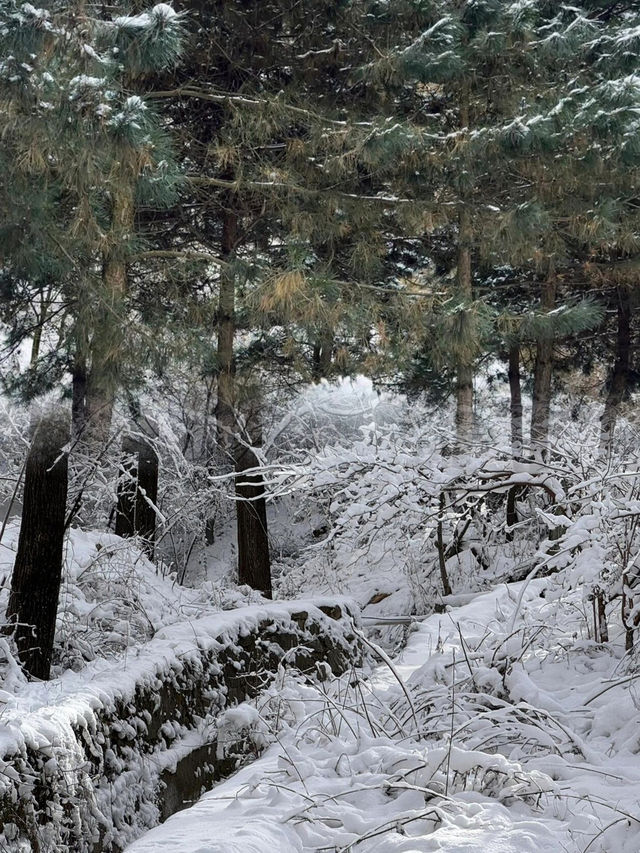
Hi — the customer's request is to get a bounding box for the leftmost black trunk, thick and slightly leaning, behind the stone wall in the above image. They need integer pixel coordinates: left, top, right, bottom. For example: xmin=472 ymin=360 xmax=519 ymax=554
xmin=7 ymin=412 xmax=69 ymax=680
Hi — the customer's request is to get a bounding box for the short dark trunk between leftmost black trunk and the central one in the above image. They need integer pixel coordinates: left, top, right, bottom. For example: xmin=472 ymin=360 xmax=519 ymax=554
xmin=116 ymin=436 xmax=158 ymax=560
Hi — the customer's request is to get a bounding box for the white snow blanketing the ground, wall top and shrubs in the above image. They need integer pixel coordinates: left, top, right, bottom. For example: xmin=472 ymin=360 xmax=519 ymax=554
xmin=0 ymin=380 xmax=640 ymax=853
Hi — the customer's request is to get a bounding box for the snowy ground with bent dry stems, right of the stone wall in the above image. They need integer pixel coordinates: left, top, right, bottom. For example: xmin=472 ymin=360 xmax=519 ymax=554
xmin=128 ymin=579 xmax=640 ymax=853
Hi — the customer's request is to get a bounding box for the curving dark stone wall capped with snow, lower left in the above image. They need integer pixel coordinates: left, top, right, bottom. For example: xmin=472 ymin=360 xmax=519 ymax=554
xmin=0 ymin=600 xmax=361 ymax=853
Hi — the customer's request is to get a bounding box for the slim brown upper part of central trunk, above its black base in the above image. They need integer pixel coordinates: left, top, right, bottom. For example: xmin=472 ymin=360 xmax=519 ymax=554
xmin=216 ymin=203 xmax=238 ymax=458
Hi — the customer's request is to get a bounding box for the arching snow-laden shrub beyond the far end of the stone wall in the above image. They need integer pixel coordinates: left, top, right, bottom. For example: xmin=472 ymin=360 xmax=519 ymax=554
xmin=272 ymin=409 xmax=549 ymax=614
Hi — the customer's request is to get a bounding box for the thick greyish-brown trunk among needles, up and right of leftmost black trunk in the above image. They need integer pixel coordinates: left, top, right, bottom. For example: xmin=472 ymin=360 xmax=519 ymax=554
xmin=86 ymin=180 xmax=136 ymax=445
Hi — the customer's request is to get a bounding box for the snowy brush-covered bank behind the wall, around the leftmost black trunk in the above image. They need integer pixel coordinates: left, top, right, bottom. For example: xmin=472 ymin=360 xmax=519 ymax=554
xmin=0 ymin=519 xmax=260 ymax=696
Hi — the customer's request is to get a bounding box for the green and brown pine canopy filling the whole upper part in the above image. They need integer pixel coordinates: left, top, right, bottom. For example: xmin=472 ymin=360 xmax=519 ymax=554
xmin=0 ymin=0 xmax=640 ymax=552
